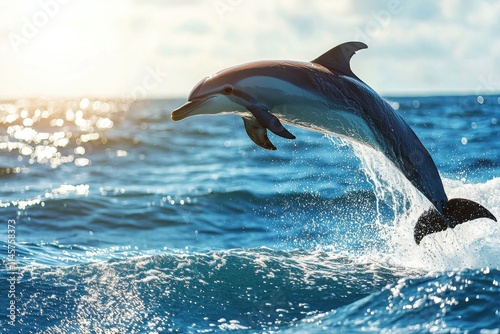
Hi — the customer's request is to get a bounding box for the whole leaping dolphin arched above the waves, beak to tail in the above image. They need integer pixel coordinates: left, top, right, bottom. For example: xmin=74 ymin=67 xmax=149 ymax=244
xmin=171 ymin=42 xmax=496 ymax=244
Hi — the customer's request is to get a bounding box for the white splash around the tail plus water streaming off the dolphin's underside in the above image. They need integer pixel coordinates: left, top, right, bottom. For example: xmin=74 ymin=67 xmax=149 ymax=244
xmin=349 ymin=137 xmax=500 ymax=271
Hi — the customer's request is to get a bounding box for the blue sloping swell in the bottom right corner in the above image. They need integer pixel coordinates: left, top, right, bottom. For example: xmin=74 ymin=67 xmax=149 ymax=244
xmin=290 ymin=267 xmax=500 ymax=333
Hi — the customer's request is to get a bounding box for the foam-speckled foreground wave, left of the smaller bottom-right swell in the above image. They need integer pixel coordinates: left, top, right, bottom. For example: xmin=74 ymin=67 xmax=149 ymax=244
xmin=0 ymin=248 xmax=408 ymax=333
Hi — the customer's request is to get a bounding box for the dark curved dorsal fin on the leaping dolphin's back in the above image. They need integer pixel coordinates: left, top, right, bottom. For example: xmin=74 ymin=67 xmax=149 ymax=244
xmin=312 ymin=42 xmax=368 ymax=80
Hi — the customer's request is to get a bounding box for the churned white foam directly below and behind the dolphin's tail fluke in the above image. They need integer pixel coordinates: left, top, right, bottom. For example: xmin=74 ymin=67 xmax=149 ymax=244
xmin=392 ymin=178 xmax=500 ymax=271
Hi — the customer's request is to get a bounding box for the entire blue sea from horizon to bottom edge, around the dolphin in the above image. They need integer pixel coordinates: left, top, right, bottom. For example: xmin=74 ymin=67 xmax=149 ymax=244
xmin=0 ymin=96 xmax=500 ymax=333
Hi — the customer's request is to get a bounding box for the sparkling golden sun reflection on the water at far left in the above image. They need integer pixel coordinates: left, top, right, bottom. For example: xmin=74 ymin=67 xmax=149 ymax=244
xmin=0 ymin=97 xmax=128 ymax=170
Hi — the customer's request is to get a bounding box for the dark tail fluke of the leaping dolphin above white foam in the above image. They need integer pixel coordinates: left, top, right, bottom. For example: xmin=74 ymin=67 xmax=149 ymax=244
xmin=414 ymin=198 xmax=497 ymax=245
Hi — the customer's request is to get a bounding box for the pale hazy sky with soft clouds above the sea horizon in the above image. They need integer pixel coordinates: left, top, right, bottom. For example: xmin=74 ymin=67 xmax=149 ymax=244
xmin=0 ymin=0 xmax=500 ymax=99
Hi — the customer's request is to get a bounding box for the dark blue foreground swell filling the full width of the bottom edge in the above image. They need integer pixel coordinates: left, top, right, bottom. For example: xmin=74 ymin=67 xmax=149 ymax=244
xmin=0 ymin=245 xmax=500 ymax=333
